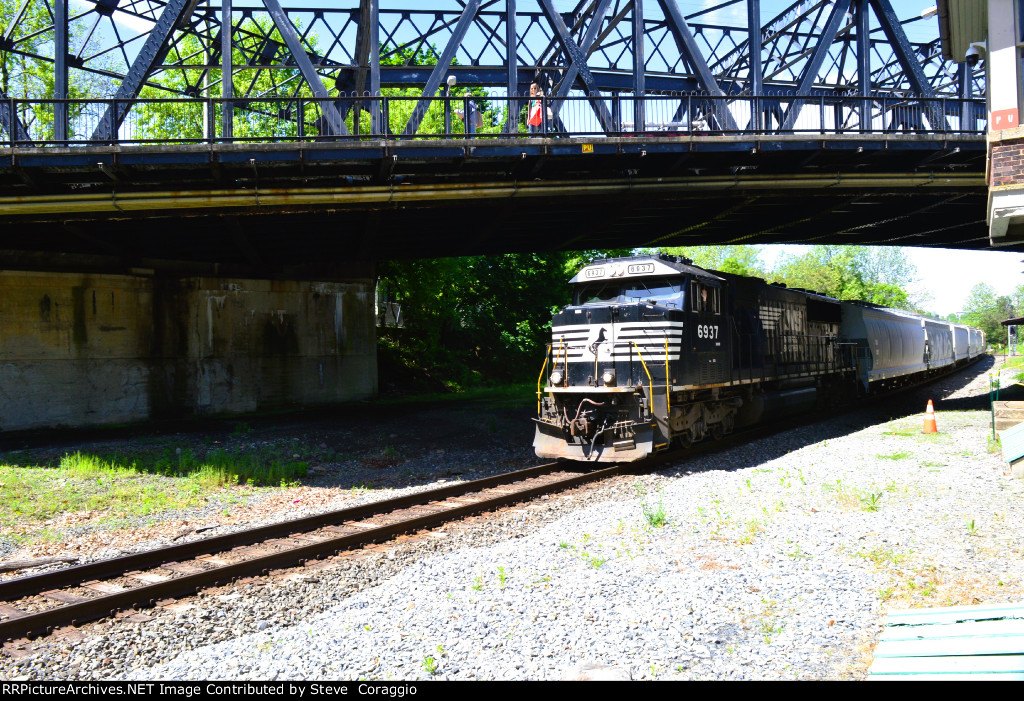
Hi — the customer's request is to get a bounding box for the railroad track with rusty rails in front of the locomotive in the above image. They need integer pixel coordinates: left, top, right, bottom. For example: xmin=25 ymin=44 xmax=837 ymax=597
xmin=0 ymin=457 xmax=647 ymax=641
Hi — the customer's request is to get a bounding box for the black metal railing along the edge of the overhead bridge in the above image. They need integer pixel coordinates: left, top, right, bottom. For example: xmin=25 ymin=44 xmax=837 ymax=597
xmin=0 ymin=93 xmax=987 ymax=147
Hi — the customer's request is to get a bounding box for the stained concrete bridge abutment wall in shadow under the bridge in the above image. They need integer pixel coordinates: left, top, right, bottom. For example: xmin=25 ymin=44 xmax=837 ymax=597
xmin=0 ymin=266 xmax=377 ymax=431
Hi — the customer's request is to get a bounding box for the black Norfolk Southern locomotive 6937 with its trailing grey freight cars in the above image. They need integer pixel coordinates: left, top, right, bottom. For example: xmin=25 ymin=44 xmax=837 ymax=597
xmin=534 ymin=255 xmax=985 ymax=462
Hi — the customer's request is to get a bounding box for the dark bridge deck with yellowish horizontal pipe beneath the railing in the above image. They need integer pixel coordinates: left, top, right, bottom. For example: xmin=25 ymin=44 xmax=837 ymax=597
xmin=0 ymin=133 xmax=987 ymax=274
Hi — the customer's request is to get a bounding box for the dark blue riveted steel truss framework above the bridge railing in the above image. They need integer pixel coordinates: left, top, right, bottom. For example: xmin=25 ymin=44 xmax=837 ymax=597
xmin=0 ymin=0 xmax=985 ymax=140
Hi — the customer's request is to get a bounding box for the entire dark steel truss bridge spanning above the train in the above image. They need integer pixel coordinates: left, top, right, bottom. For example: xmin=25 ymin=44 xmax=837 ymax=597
xmin=0 ymin=0 xmax=999 ymax=274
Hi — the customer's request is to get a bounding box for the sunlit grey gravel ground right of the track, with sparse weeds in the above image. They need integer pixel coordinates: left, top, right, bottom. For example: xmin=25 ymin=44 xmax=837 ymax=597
xmin=0 ymin=361 xmax=1024 ymax=681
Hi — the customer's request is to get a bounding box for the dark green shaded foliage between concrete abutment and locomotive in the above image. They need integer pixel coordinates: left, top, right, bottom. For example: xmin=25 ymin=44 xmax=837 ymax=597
xmin=378 ymin=251 xmax=626 ymax=390
